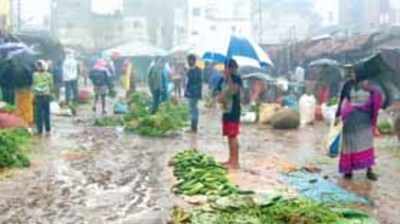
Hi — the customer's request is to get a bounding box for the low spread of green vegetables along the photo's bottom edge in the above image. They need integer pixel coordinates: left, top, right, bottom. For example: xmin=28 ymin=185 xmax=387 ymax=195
xmin=172 ymin=195 xmax=376 ymax=224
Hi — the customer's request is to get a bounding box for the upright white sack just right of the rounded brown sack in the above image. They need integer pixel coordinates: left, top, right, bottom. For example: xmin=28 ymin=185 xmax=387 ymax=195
xmin=299 ymin=94 xmax=317 ymax=126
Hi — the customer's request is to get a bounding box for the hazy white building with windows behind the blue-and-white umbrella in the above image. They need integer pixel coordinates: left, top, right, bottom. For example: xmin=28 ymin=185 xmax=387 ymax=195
xmin=180 ymin=0 xmax=253 ymax=45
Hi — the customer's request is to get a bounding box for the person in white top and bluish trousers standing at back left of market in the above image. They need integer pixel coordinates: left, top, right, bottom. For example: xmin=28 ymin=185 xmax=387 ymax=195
xmin=63 ymin=52 xmax=79 ymax=104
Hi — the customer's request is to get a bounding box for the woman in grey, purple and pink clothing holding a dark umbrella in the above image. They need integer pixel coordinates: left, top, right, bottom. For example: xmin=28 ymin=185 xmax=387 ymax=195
xmin=337 ymin=80 xmax=383 ymax=181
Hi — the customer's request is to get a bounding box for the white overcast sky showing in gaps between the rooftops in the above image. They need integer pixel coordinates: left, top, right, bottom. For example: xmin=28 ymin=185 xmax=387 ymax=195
xmin=23 ymin=0 xmax=338 ymax=24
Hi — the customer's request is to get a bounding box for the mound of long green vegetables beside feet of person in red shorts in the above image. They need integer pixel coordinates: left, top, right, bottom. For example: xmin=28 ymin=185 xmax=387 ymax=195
xmin=171 ymin=150 xmax=251 ymax=196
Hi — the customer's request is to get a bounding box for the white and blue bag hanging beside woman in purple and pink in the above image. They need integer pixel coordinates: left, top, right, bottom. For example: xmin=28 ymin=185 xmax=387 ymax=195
xmin=326 ymin=121 xmax=343 ymax=158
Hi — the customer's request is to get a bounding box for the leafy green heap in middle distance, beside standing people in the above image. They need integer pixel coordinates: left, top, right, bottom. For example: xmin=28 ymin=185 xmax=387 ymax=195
xmin=125 ymin=93 xmax=188 ymax=137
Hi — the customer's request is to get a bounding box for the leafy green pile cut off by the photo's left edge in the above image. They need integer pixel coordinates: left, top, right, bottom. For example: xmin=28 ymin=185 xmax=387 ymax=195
xmin=0 ymin=129 xmax=31 ymax=168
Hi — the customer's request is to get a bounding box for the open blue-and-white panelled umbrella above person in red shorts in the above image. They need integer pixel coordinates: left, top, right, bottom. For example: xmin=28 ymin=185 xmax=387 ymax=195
xmin=200 ymin=35 xmax=273 ymax=67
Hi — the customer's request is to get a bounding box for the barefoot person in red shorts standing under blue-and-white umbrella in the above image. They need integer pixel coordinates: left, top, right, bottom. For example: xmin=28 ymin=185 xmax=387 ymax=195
xmin=217 ymin=59 xmax=242 ymax=169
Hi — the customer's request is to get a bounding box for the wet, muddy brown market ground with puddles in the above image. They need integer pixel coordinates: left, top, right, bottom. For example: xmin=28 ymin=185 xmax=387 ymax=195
xmin=0 ymin=103 xmax=400 ymax=224
